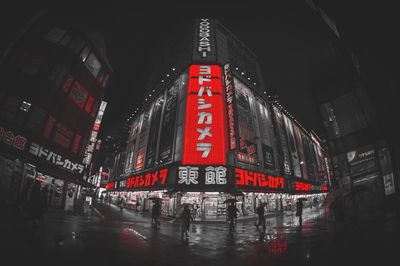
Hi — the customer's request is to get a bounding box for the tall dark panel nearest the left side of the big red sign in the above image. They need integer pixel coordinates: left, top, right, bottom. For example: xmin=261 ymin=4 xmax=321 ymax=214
xmin=158 ymin=79 xmax=179 ymax=162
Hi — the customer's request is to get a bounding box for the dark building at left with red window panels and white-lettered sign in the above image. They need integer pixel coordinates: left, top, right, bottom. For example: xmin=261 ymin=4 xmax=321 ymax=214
xmin=0 ymin=12 xmax=112 ymax=208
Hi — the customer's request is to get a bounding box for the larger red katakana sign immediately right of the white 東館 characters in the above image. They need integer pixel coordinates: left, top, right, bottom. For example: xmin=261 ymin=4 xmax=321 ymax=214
xmin=235 ymin=168 xmax=285 ymax=190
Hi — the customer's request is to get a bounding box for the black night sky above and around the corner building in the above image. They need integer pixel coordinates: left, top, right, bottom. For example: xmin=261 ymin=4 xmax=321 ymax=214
xmin=0 ymin=0 xmax=400 ymax=139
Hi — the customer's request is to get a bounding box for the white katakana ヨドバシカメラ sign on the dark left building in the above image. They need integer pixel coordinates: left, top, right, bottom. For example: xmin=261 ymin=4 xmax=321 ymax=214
xmin=29 ymin=142 xmax=85 ymax=174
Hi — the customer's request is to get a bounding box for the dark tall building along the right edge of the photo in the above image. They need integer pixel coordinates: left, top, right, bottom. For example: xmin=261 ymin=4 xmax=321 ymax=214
xmin=306 ymin=0 xmax=399 ymax=212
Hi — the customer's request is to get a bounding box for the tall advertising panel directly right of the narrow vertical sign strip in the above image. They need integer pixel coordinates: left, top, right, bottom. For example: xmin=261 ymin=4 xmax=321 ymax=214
xmin=233 ymin=78 xmax=258 ymax=165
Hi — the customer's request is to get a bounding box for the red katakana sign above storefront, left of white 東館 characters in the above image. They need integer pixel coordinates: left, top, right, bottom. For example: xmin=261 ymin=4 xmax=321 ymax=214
xmin=126 ymin=168 xmax=168 ymax=189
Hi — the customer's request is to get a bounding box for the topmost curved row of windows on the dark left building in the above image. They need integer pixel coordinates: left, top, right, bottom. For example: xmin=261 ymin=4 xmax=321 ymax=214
xmin=45 ymin=27 xmax=109 ymax=87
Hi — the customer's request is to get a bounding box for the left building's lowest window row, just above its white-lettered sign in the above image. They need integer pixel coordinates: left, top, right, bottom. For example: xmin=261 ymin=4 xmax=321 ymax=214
xmin=0 ymin=92 xmax=87 ymax=156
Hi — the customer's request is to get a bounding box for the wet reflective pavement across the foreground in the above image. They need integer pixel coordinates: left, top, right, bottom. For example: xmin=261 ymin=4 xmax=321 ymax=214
xmin=0 ymin=200 xmax=400 ymax=266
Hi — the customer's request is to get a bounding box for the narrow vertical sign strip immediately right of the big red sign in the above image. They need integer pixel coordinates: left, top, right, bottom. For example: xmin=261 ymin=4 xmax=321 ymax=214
xmin=224 ymin=64 xmax=236 ymax=150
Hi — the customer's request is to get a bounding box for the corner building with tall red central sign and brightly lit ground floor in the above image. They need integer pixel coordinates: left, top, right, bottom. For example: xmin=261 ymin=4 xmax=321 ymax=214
xmin=107 ymin=19 xmax=329 ymax=219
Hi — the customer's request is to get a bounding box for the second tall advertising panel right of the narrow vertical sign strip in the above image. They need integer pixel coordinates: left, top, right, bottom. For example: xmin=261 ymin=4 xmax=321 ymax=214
xmin=256 ymin=98 xmax=275 ymax=170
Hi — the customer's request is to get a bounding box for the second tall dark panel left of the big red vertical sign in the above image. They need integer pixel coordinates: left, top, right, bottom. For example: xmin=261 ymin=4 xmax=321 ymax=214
xmin=145 ymin=95 xmax=164 ymax=168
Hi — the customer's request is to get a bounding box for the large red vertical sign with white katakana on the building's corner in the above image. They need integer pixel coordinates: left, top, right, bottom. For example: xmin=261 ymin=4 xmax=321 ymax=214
xmin=182 ymin=65 xmax=226 ymax=164
